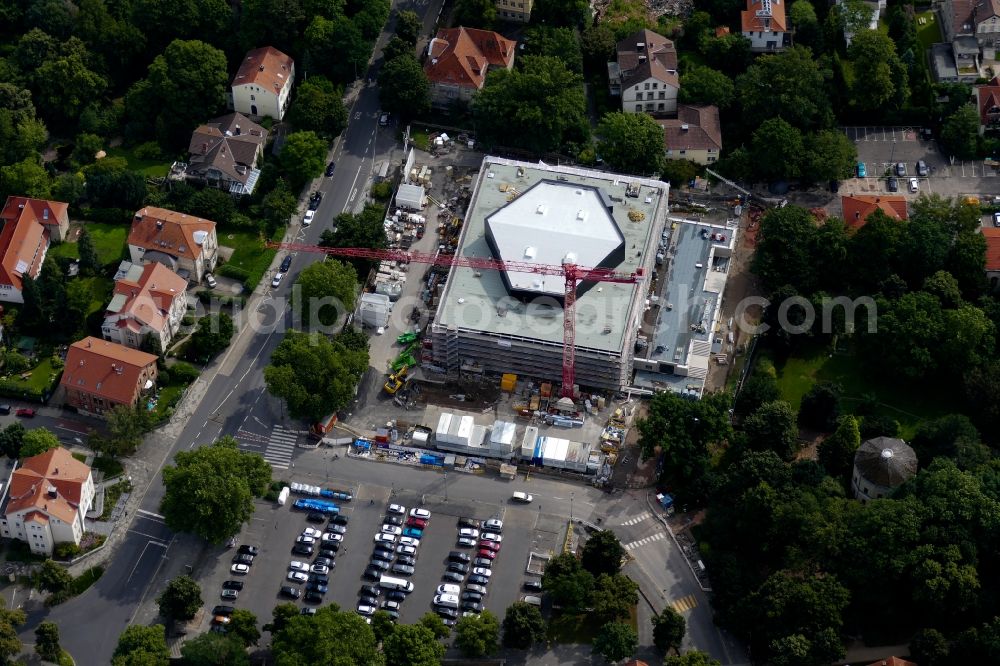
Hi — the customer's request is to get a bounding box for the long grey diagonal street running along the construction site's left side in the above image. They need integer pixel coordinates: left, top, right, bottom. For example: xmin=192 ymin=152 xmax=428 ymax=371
xmin=20 ymin=0 xmax=442 ymax=664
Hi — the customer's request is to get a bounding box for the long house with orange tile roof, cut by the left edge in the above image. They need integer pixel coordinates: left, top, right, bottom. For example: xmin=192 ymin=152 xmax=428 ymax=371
xmin=0 ymin=196 xmax=69 ymax=303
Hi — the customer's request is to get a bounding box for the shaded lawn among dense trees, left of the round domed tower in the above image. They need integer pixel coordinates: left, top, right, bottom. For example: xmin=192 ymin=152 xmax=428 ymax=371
xmin=758 ymin=345 xmax=959 ymax=439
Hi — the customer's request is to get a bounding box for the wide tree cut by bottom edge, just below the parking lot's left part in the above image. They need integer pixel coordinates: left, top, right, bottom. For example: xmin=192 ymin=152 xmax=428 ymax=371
xmin=271 ymin=605 xmax=385 ymax=666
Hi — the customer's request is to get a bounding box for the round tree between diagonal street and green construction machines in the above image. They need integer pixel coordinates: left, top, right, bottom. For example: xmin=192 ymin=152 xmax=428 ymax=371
xmin=264 ymin=330 xmax=368 ymax=421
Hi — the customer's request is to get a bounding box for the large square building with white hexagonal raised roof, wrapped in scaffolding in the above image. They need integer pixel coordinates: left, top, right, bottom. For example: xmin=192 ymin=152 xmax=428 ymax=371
xmin=431 ymin=157 xmax=669 ymax=390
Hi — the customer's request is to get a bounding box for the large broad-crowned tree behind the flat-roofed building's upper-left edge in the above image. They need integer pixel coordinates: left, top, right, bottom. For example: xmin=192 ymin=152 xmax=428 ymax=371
xmin=472 ymin=56 xmax=590 ymax=153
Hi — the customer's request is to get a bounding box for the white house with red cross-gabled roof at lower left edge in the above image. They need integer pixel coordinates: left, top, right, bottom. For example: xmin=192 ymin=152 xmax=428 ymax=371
xmin=0 ymin=447 xmax=94 ymax=557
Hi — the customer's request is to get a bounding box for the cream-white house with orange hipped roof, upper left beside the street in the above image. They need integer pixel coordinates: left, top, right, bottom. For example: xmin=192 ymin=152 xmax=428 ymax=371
xmin=230 ymin=46 xmax=295 ymax=120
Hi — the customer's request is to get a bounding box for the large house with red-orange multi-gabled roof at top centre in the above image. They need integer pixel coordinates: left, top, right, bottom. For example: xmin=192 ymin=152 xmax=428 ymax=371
xmin=424 ymin=27 xmax=517 ymax=108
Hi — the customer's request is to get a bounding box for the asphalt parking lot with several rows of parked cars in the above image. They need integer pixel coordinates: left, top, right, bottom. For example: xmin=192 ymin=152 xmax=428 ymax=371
xmin=191 ymin=472 xmax=566 ymax=629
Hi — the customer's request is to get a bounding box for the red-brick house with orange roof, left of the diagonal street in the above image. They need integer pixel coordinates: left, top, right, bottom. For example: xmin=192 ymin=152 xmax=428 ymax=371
xmin=60 ymin=337 xmax=157 ymax=415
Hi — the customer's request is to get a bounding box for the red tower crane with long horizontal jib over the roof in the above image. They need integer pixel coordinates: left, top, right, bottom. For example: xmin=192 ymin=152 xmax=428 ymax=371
xmin=267 ymin=242 xmax=643 ymax=398
